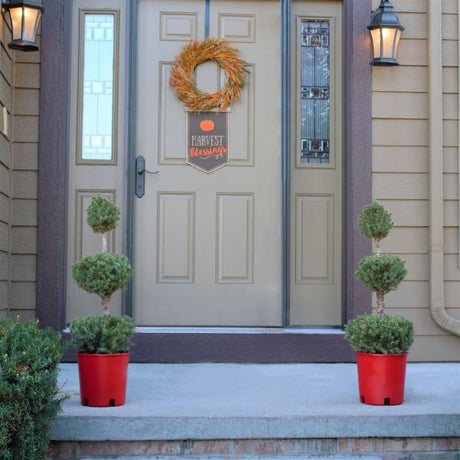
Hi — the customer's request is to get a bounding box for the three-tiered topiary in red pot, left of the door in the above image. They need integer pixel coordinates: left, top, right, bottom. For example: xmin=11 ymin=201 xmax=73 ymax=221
xmin=70 ymin=195 xmax=135 ymax=407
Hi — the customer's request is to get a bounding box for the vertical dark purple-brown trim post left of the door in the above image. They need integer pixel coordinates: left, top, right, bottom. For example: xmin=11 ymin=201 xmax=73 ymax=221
xmin=37 ymin=0 xmax=71 ymax=329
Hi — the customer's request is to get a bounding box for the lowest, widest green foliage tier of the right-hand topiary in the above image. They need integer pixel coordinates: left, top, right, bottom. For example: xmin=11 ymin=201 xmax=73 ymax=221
xmin=345 ymin=315 xmax=414 ymax=354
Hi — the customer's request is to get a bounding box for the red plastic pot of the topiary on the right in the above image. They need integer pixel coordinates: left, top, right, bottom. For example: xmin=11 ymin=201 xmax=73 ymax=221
xmin=356 ymin=353 xmax=407 ymax=405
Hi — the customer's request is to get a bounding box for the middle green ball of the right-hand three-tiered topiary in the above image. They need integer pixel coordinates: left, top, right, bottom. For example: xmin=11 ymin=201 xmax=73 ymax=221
xmin=355 ymin=254 xmax=407 ymax=294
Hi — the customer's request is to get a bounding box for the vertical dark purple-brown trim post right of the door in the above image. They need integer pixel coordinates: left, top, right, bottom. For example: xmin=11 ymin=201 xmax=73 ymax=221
xmin=343 ymin=0 xmax=372 ymax=322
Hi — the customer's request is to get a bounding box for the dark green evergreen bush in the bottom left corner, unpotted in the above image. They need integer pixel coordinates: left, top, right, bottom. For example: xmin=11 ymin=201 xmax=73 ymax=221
xmin=0 ymin=317 xmax=64 ymax=460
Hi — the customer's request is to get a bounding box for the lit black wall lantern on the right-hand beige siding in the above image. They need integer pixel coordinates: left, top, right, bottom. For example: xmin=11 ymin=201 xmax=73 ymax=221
xmin=367 ymin=0 xmax=404 ymax=65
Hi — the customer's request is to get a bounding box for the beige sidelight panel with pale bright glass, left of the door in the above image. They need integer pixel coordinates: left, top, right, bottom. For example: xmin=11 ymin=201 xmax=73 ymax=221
xmin=66 ymin=0 xmax=128 ymax=322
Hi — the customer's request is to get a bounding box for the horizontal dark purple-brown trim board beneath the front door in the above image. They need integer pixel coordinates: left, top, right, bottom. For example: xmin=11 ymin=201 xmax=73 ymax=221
xmin=64 ymin=332 xmax=354 ymax=364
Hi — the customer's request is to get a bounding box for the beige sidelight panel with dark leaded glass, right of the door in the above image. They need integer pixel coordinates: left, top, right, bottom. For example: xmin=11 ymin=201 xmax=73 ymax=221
xmin=289 ymin=0 xmax=343 ymax=326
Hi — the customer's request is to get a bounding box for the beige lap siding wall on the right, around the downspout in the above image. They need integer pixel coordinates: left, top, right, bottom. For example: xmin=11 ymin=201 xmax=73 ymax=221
xmin=372 ymin=0 xmax=460 ymax=361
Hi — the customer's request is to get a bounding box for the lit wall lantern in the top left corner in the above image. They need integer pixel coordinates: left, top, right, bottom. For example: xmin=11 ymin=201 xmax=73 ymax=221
xmin=2 ymin=0 xmax=43 ymax=51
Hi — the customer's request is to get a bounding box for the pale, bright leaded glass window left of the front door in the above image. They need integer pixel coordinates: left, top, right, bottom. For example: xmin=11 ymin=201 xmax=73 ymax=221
xmin=79 ymin=12 xmax=117 ymax=161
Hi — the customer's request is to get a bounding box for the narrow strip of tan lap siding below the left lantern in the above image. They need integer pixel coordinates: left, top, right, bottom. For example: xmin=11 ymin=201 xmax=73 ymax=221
xmin=8 ymin=33 xmax=40 ymax=320
